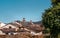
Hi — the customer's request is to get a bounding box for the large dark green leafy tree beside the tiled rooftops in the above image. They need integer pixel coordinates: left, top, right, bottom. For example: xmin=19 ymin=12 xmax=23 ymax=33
xmin=42 ymin=0 xmax=60 ymax=38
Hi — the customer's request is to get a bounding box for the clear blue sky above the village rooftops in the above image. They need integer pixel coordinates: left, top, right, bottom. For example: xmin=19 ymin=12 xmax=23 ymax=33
xmin=0 ymin=0 xmax=51 ymax=23
